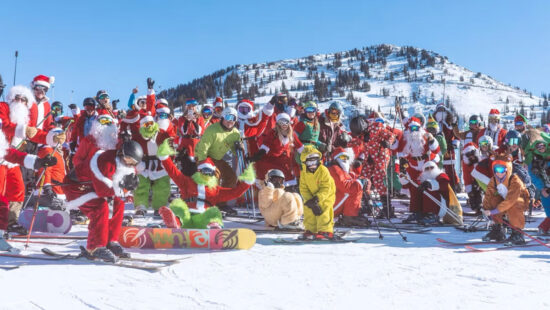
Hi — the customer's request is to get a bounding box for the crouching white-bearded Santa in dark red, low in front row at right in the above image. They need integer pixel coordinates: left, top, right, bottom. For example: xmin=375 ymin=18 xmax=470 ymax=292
xmin=402 ymin=161 xmax=463 ymax=225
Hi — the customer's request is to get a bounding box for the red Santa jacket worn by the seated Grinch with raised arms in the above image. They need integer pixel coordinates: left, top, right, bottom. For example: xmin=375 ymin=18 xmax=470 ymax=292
xmin=162 ymin=157 xmax=250 ymax=212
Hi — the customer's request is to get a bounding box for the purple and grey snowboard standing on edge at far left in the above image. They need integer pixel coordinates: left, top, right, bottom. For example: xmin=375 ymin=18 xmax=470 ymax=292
xmin=19 ymin=209 xmax=72 ymax=234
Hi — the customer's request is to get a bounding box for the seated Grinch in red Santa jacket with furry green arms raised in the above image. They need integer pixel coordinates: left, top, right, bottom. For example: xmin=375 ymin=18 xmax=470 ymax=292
xmin=157 ymin=140 xmax=256 ymax=228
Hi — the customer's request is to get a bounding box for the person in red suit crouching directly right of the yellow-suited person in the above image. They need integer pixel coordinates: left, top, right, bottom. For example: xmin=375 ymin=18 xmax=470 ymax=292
xmin=328 ymin=147 xmax=370 ymax=227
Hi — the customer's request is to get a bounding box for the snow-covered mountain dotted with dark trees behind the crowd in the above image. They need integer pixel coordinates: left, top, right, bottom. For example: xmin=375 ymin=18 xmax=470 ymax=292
xmin=161 ymin=44 xmax=548 ymax=125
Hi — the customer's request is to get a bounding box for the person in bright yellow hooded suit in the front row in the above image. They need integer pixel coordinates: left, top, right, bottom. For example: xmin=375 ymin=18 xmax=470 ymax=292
xmin=300 ymin=145 xmax=336 ymax=239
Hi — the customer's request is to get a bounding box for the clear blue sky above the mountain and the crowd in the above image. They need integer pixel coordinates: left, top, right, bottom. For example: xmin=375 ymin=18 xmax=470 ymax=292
xmin=0 ymin=0 xmax=550 ymax=109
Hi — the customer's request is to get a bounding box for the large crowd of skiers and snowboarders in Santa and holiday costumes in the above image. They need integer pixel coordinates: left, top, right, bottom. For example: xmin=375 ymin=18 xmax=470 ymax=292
xmin=0 ymin=75 xmax=550 ymax=261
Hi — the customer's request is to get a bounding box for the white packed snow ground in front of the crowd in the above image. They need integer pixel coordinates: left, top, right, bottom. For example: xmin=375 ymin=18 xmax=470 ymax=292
xmin=0 ymin=202 xmax=550 ymax=309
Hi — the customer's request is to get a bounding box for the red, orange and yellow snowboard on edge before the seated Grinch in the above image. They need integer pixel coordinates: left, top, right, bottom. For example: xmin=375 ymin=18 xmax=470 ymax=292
xmin=119 ymin=227 xmax=256 ymax=250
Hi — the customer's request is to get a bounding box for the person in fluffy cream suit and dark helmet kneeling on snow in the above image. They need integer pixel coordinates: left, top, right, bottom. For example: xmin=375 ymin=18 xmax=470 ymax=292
xmin=256 ymin=169 xmax=304 ymax=229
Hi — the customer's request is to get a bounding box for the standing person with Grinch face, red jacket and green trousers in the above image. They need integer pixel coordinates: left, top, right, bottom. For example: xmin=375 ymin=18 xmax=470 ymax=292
xmin=133 ymin=110 xmax=174 ymax=216
